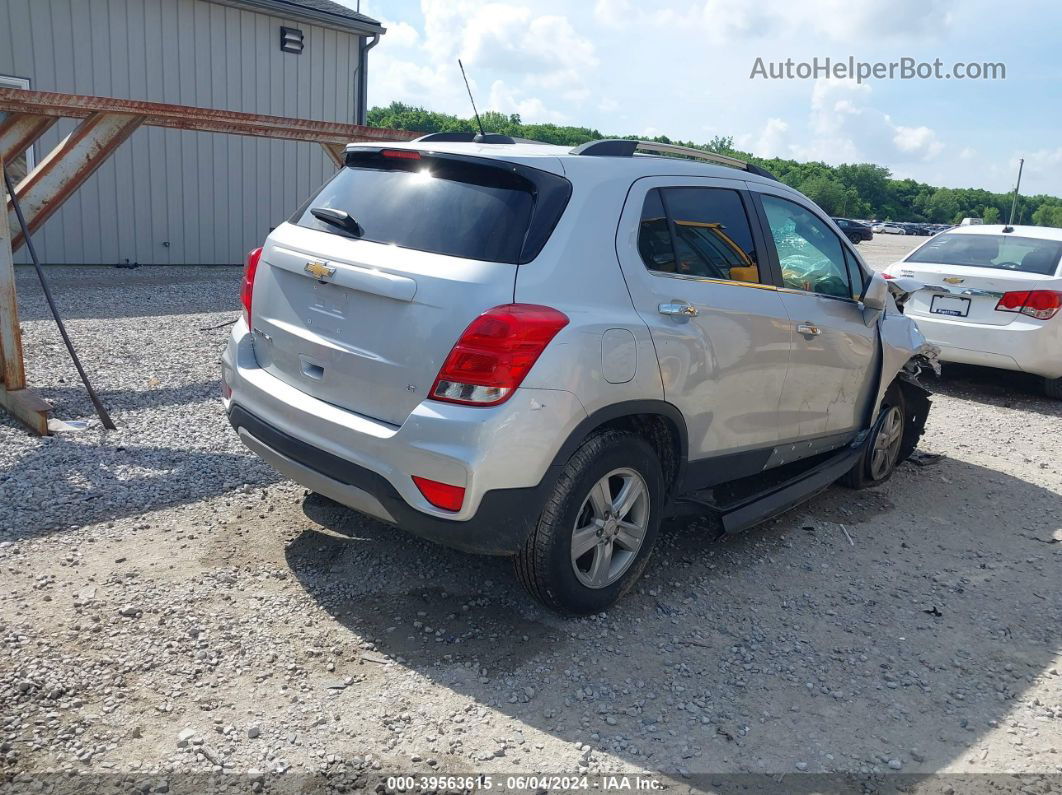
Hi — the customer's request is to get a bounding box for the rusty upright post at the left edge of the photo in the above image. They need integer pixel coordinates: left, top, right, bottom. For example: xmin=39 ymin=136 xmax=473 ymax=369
xmin=0 ymin=152 xmax=51 ymax=436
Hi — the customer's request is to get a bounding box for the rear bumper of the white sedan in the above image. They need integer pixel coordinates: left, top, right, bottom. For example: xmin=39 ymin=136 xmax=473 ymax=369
xmin=909 ymin=315 xmax=1062 ymax=378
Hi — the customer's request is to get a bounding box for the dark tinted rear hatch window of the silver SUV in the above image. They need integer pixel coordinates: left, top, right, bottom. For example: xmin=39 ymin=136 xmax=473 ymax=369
xmin=291 ymin=149 xmax=571 ymax=264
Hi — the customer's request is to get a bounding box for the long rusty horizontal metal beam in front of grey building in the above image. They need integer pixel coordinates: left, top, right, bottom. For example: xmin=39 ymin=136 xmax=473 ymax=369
xmin=0 ymin=88 xmax=419 ymax=144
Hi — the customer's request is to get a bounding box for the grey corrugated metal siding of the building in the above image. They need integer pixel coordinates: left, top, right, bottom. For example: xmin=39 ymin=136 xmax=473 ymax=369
xmin=0 ymin=0 xmax=359 ymax=264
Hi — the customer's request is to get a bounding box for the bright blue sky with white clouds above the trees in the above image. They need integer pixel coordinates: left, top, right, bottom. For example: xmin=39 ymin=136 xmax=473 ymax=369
xmin=341 ymin=0 xmax=1062 ymax=195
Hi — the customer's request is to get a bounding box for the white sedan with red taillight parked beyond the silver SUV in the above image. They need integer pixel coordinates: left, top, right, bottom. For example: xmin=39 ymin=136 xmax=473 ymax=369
xmin=884 ymin=226 xmax=1062 ymax=398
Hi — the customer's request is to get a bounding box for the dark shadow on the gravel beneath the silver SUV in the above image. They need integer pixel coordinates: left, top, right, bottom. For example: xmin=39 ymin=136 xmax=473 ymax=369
xmin=286 ymin=460 xmax=1062 ymax=774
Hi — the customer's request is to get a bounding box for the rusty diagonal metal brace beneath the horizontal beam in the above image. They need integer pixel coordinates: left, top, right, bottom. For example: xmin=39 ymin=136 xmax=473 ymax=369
xmin=6 ymin=113 xmax=143 ymax=252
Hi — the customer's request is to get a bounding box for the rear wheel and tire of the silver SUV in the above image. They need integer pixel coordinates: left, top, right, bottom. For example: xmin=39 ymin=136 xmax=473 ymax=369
xmin=515 ymin=431 xmax=665 ymax=616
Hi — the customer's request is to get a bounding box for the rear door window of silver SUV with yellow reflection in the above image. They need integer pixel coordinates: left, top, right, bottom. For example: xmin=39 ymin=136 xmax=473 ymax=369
xmin=638 ymin=188 xmax=759 ymax=283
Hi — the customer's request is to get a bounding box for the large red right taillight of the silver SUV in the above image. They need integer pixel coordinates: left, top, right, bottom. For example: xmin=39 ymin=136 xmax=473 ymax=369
xmin=430 ymin=304 xmax=568 ymax=405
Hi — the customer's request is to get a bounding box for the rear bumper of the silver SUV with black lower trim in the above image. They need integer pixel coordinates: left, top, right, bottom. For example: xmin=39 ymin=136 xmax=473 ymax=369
xmin=222 ymin=319 xmax=586 ymax=554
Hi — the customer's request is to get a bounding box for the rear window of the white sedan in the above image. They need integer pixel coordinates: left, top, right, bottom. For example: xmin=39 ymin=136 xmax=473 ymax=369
xmin=905 ymin=234 xmax=1062 ymax=276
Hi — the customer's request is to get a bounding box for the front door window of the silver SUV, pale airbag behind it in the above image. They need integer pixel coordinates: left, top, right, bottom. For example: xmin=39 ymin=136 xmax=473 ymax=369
xmin=761 ymin=194 xmax=852 ymax=298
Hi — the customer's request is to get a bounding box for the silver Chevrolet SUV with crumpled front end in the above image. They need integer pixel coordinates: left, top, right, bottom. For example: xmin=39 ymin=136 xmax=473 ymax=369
xmin=223 ymin=134 xmax=932 ymax=613
